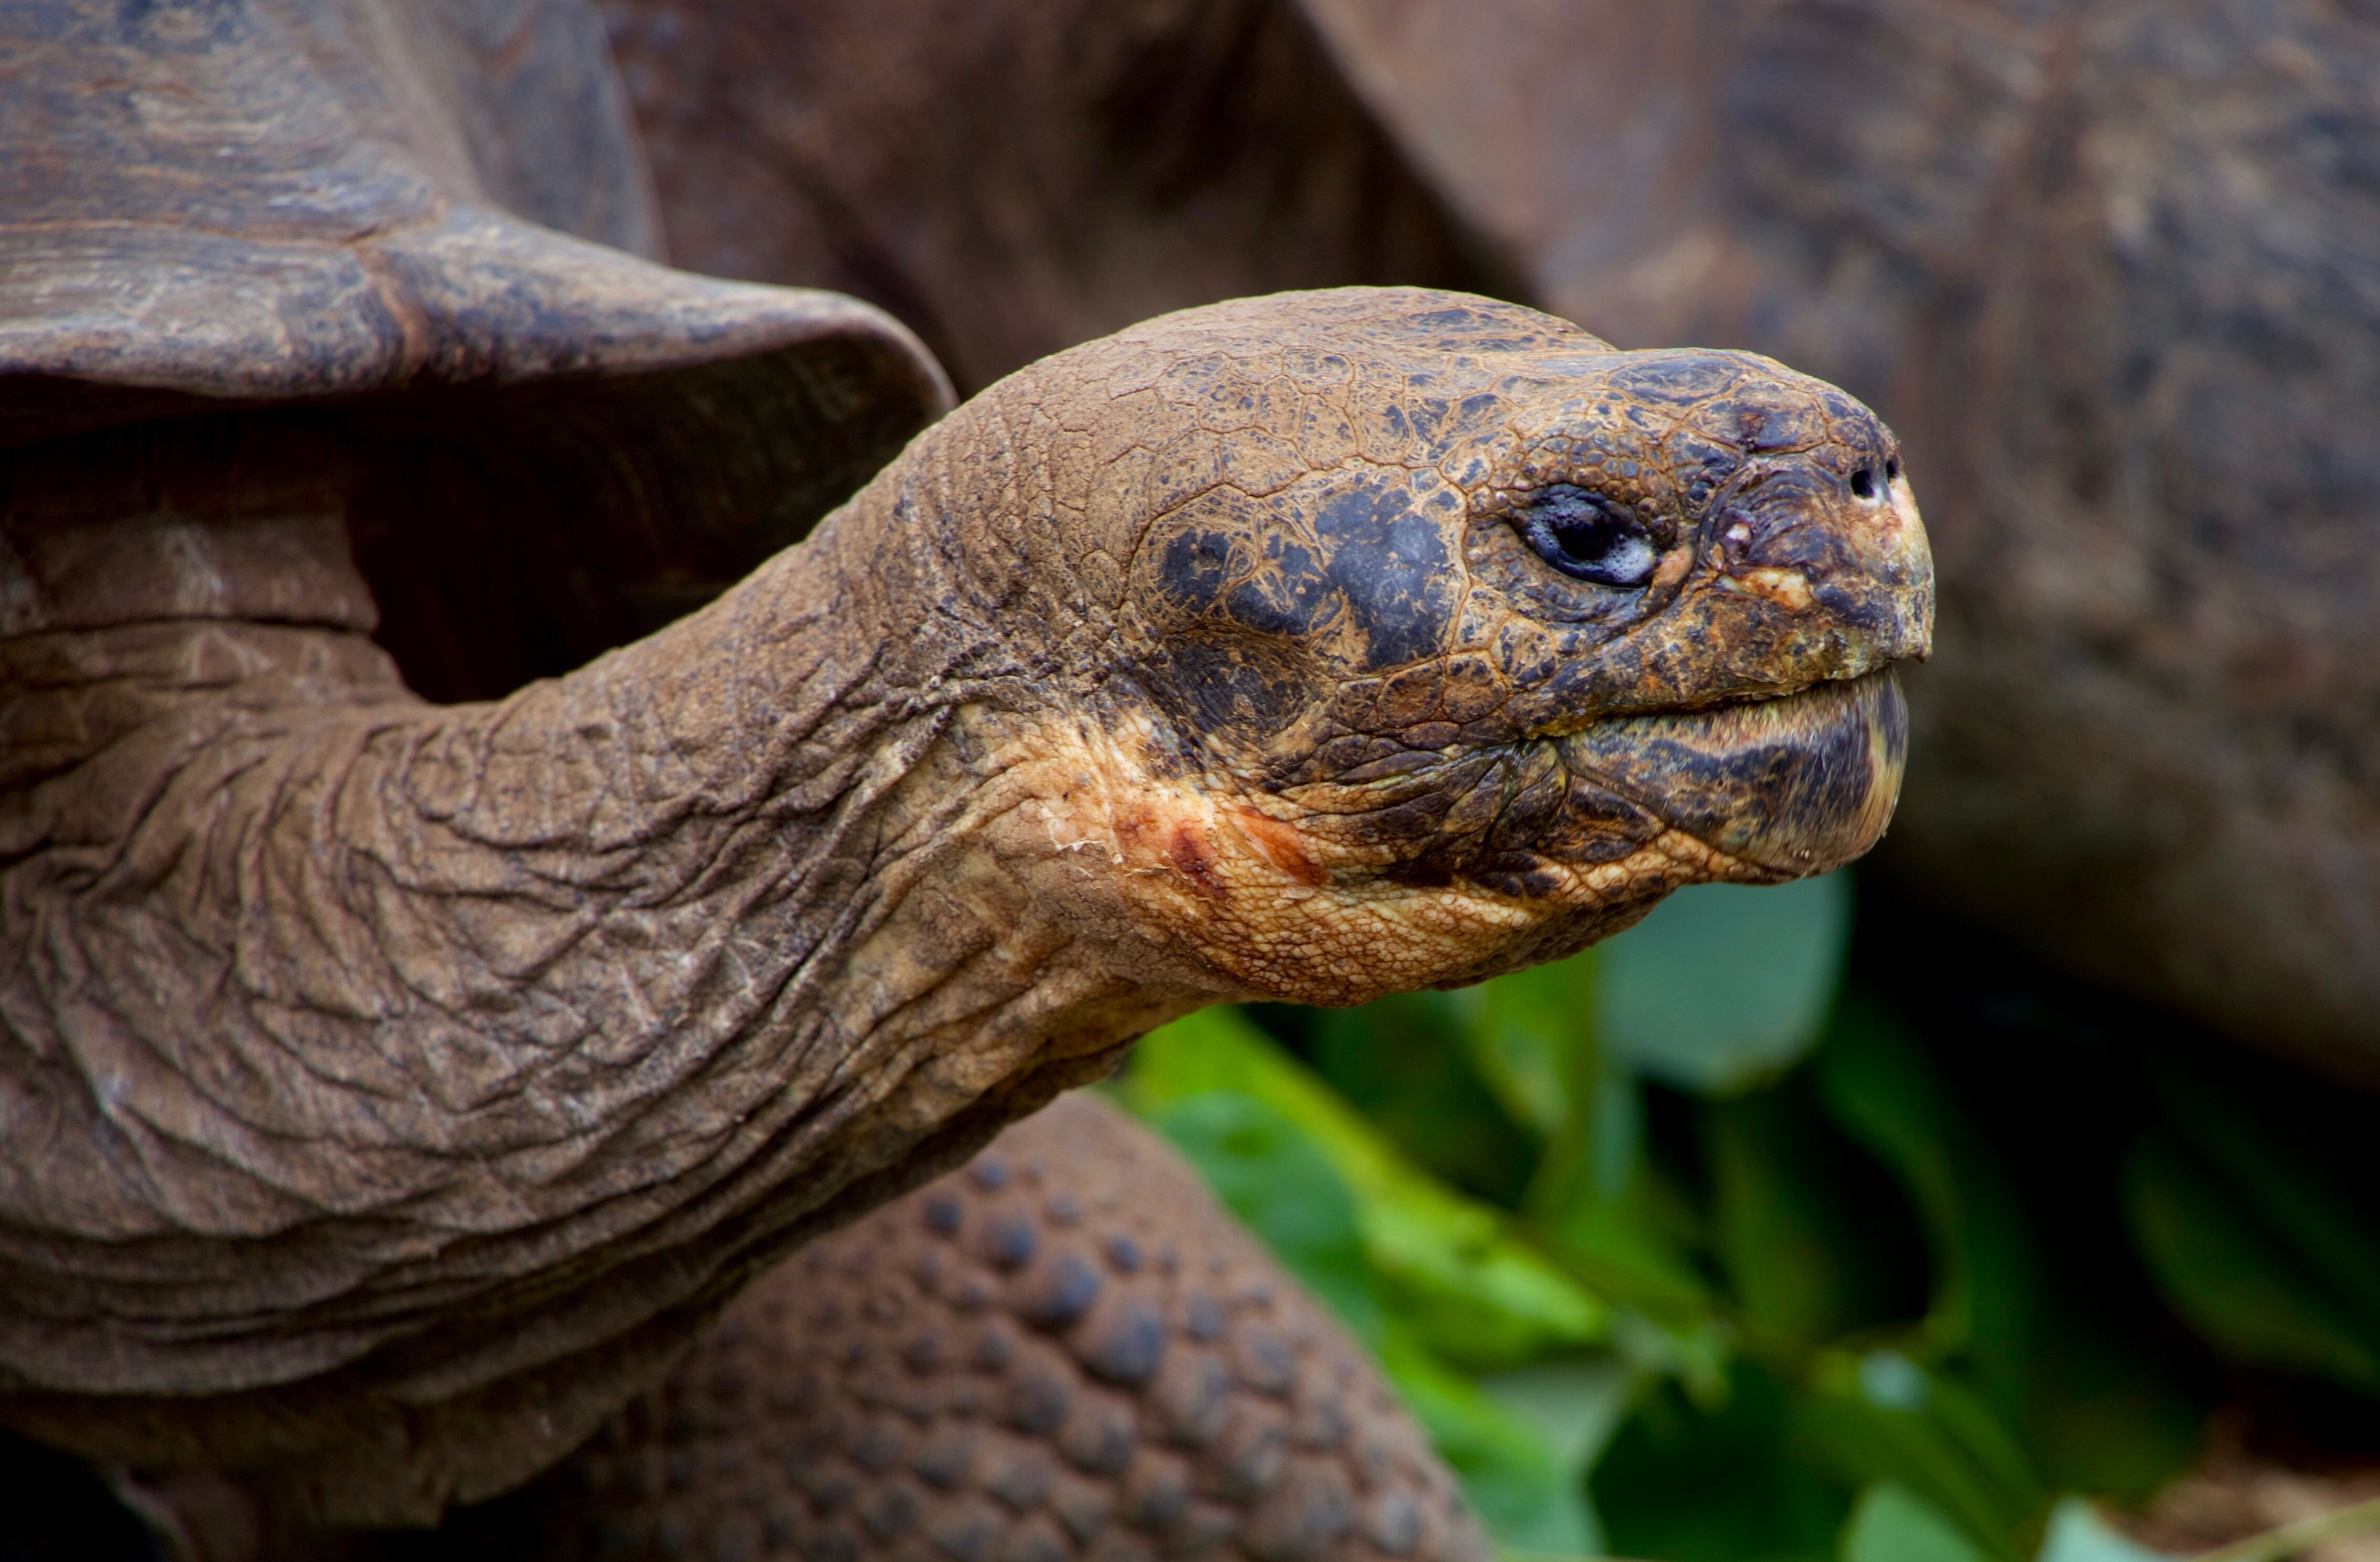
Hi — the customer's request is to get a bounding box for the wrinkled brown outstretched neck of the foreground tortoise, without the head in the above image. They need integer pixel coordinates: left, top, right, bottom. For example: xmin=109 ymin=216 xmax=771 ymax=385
xmin=0 ymin=410 xmax=1216 ymax=1522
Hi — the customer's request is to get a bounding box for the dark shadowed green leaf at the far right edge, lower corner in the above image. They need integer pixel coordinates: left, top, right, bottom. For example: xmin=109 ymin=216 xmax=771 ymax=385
xmin=2123 ymin=1134 xmax=2380 ymax=1393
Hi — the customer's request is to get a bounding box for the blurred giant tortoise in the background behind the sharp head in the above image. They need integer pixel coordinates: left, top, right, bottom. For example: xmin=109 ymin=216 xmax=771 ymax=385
xmin=607 ymin=0 xmax=2380 ymax=1079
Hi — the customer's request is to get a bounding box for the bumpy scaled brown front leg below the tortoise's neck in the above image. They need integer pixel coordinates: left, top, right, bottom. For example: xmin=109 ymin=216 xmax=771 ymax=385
xmin=471 ymin=1095 xmax=1488 ymax=1562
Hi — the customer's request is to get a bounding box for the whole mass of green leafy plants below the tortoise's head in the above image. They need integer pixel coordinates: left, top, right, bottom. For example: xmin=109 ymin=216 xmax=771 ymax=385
xmin=1118 ymin=876 xmax=2380 ymax=1562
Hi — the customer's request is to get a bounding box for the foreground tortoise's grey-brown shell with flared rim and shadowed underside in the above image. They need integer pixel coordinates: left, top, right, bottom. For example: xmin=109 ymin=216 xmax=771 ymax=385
xmin=0 ymin=0 xmax=950 ymax=698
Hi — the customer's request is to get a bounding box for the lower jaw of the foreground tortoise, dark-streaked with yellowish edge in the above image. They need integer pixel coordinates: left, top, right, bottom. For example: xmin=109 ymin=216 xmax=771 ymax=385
xmin=1559 ymin=667 xmax=1909 ymax=879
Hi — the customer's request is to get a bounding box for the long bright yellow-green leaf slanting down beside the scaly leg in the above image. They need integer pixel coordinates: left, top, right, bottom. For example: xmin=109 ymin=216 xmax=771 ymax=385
xmin=1118 ymin=1009 xmax=1609 ymax=1367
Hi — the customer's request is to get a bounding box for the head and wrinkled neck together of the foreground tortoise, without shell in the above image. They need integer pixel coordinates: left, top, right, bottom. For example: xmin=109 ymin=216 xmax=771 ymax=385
xmin=0 ymin=290 xmax=1933 ymax=1524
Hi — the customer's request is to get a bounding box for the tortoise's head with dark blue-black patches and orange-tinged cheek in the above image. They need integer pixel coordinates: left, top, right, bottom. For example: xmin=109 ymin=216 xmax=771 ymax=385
xmin=928 ymin=290 xmax=1933 ymax=1003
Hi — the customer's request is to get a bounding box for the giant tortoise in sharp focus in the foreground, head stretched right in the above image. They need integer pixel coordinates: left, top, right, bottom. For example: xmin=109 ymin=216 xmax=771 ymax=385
xmin=0 ymin=0 xmax=1933 ymax=1562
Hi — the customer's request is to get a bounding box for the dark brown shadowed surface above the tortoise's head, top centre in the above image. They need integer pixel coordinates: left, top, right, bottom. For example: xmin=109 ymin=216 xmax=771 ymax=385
xmin=602 ymin=0 xmax=1523 ymax=393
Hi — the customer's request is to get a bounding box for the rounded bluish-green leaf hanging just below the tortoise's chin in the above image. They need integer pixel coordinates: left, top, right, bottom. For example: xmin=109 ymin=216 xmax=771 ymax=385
xmin=1595 ymin=874 xmax=1851 ymax=1095
